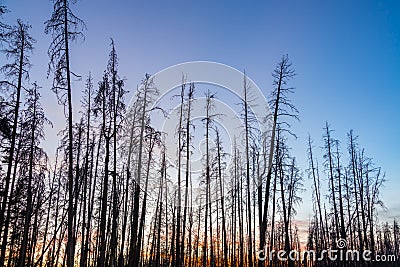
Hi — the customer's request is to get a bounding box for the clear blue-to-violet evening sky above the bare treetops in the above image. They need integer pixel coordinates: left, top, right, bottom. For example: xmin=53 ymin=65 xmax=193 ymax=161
xmin=1 ymin=0 xmax=400 ymax=228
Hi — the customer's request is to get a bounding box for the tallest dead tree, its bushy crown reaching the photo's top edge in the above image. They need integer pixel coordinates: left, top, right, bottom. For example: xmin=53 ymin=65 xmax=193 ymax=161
xmin=45 ymin=0 xmax=85 ymax=267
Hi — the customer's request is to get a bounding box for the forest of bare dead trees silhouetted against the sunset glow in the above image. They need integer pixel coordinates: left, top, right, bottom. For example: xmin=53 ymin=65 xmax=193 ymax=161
xmin=0 ymin=0 xmax=400 ymax=267
